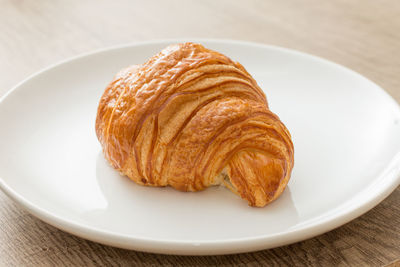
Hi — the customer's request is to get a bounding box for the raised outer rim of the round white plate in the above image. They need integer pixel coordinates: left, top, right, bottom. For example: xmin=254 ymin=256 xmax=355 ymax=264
xmin=0 ymin=38 xmax=400 ymax=255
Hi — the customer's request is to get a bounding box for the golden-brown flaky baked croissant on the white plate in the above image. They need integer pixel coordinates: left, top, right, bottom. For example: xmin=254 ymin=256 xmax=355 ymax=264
xmin=96 ymin=43 xmax=294 ymax=207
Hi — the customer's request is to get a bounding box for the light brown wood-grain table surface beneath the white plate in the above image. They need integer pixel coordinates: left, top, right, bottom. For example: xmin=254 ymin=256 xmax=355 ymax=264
xmin=0 ymin=0 xmax=400 ymax=266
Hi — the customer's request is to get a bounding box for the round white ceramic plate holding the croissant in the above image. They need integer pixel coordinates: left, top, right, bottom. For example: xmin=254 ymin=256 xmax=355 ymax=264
xmin=0 ymin=40 xmax=400 ymax=255
